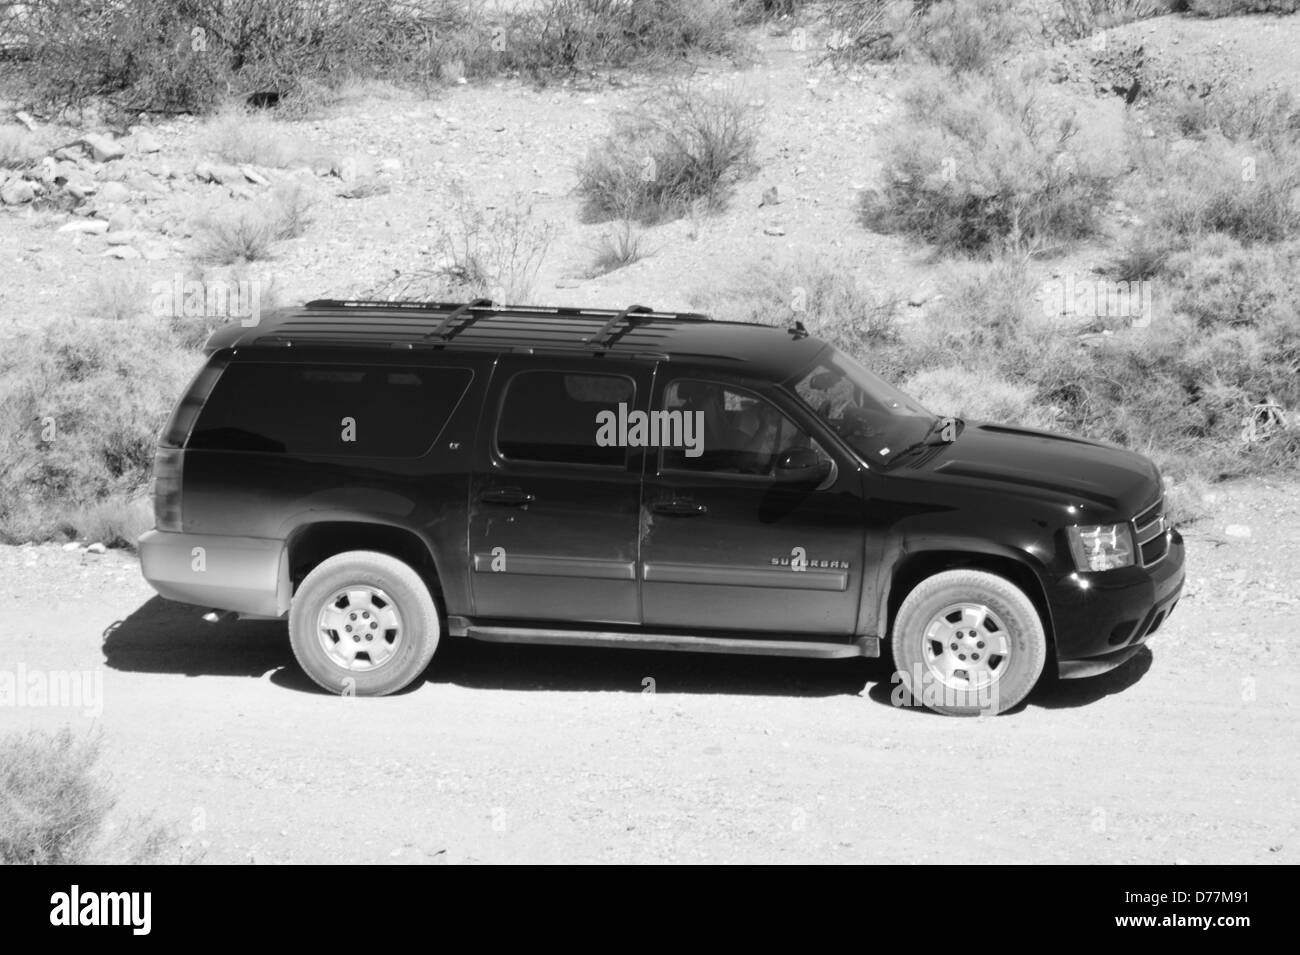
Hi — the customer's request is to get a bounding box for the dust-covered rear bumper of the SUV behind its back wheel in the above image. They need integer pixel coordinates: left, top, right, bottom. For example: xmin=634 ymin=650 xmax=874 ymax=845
xmin=138 ymin=530 xmax=290 ymax=617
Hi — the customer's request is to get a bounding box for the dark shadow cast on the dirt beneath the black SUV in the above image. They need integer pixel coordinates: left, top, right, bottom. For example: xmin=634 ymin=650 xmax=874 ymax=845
xmin=103 ymin=596 xmax=1152 ymax=716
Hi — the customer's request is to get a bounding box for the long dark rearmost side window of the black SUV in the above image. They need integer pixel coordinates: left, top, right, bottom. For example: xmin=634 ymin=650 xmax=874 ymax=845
xmin=187 ymin=361 xmax=472 ymax=457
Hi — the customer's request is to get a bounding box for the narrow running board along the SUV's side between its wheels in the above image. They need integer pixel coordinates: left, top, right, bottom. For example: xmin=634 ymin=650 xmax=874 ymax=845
xmin=447 ymin=617 xmax=880 ymax=660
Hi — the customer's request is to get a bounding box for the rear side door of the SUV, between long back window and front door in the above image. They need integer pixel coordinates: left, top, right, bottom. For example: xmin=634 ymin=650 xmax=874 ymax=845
xmin=469 ymin=357 xmax=651 ymax=625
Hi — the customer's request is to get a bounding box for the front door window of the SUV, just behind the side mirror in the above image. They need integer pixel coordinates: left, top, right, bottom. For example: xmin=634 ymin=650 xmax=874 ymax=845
xmin=662 ymin=378 xmax=829 ymax=477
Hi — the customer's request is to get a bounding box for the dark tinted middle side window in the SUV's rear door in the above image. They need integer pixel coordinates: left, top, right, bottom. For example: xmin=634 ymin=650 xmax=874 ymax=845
xmin=497 ymin=372 xmax=636 ymax=466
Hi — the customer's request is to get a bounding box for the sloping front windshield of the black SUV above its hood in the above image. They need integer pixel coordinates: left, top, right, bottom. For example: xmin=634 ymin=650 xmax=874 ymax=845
xmin=794 ymin=348 xmax=937 ymax=464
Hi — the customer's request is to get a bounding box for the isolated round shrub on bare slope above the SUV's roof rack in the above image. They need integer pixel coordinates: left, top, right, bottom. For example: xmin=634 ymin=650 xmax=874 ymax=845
xmin=577 ymin=86 xmax=758 ymax=222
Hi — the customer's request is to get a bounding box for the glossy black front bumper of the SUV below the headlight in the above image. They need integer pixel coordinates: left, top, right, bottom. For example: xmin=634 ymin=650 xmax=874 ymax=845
xmin=1047 ymin=530 xmax=1186 ymax=680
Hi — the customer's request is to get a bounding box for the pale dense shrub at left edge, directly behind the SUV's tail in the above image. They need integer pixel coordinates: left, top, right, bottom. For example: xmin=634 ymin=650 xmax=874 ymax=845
xmin=0 ymin=318 xmax=200 ymax=541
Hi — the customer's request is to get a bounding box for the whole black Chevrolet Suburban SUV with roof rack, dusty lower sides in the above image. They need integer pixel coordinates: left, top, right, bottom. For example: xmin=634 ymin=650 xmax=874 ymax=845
xmin=139 ymin=300 xmax=1183 ymax=713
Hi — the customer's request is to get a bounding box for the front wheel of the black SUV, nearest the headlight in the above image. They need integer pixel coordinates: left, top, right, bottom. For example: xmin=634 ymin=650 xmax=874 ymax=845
xmin=891 ymin=570 xmax=1048 ymax=716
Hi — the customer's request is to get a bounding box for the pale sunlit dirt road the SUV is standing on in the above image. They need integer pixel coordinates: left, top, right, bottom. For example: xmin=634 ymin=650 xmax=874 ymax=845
xmin=0 ymin=481 xmax=1300 ymax=864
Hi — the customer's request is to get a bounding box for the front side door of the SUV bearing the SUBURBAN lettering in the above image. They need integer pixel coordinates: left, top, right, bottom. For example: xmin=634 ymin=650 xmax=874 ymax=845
xmin=641 ymin=372 xmax=865 ymax=637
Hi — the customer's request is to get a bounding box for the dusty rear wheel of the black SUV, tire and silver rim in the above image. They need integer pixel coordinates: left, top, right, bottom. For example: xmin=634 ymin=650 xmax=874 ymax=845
xmin=289 ymin=551 xmax=442 ymax=696
